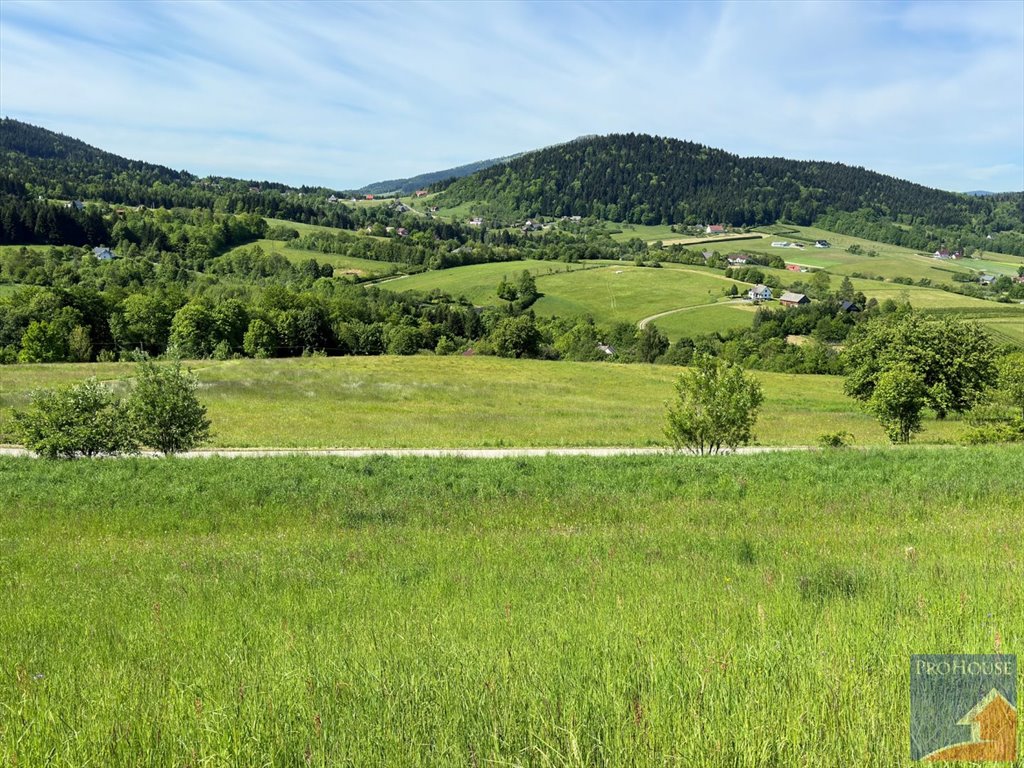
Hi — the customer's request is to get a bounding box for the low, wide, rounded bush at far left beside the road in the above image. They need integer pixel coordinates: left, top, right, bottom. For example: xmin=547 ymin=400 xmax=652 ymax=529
xmin=12 ymin=379 xmax=138 ymax=459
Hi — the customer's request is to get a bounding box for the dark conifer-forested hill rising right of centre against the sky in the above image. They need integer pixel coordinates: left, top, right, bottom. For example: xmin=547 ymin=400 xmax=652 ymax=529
xmin=434 ymin=133 xmax=1021 ymax=234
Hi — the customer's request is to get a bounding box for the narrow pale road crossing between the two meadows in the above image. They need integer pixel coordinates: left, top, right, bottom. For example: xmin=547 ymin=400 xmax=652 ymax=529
xmin=0 ymin=445 xmax=815 ymax=459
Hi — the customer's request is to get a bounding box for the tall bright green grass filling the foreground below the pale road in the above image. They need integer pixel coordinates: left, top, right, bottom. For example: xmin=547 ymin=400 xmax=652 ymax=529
xmin=0 ymin=447 xmax=1024 ymax=768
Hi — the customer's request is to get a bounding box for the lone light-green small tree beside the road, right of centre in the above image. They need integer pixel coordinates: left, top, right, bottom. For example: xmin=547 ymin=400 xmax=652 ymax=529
xmin=665 ymin=354 xmax=764 ymax=456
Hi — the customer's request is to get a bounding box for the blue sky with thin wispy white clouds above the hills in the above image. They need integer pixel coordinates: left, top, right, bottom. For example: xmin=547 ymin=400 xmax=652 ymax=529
xmin=0 ymin=0 xmax=1024 ymax=190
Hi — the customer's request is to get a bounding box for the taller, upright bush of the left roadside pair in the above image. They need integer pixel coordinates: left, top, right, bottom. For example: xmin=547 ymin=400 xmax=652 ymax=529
xmin=126 ymin=360 xmax=210 ymax=456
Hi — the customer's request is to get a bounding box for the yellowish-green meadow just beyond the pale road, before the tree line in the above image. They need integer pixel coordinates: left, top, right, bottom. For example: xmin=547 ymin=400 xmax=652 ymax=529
xmin=0 ymin=355 xmax=968 ymax=449
